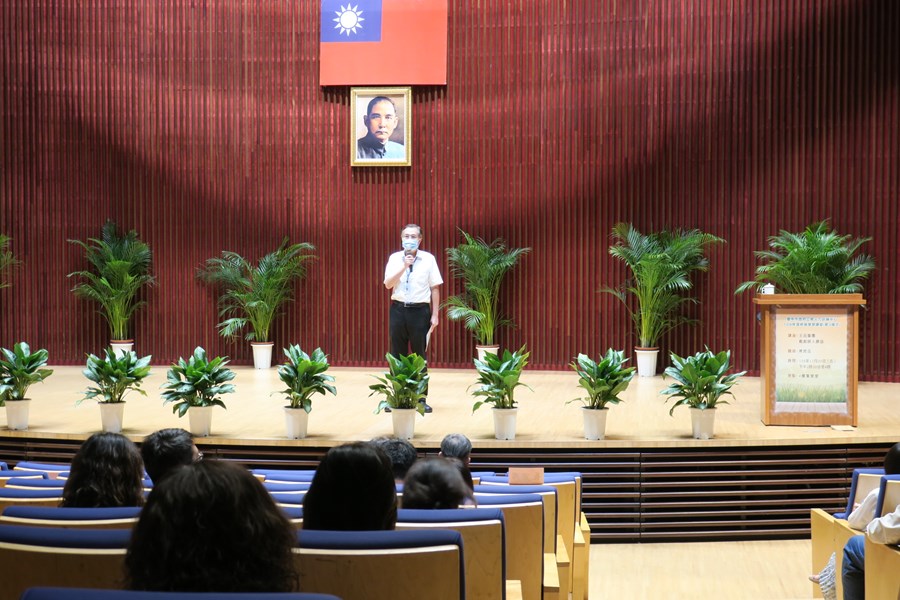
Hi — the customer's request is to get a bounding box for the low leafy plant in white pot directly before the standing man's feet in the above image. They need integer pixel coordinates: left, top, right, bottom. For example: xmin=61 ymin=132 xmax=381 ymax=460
xmin=369 ymin=353 xmax=430 ymax=440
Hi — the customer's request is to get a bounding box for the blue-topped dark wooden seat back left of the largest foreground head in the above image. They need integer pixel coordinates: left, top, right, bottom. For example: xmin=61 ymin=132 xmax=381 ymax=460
xmin=0 ymin=525 xmax=131 ymax=598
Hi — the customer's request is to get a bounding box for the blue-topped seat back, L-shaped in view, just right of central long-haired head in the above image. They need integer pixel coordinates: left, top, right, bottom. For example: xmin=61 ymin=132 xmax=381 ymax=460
xmin=397 ymin=508 xmax=506 ymax=600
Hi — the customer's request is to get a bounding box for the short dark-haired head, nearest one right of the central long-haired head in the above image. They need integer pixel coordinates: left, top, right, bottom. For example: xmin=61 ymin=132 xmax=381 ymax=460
xmin=401 ymin=458 xmax=475 ymax=509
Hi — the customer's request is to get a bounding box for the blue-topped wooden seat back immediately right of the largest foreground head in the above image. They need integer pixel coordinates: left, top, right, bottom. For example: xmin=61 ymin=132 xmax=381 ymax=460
xmin=294 ymin=529 xmax=465 ymax=600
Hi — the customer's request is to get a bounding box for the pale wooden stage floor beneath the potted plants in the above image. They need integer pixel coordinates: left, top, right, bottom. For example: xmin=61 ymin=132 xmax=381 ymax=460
xmin=0 ymin=366 xmax=900 ymax=451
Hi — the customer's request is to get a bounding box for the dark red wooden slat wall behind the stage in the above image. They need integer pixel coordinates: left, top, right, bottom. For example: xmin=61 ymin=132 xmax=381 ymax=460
xmin=0 ymin=0 xmax=900 ymax=381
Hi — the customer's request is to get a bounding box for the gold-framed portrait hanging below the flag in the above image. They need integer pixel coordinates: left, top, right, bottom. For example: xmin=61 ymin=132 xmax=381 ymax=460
xmin=350 ymin=86 xmax=412 ymax=167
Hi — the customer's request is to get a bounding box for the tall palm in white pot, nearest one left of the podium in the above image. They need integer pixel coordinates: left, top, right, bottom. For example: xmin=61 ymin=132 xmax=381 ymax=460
xmin=600 ymin=223 xmax=725 ymax=377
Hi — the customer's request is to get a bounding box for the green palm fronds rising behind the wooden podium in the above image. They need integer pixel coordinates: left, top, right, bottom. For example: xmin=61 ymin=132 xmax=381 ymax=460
xmin=735 ymin=221 xmax=875 ymax=294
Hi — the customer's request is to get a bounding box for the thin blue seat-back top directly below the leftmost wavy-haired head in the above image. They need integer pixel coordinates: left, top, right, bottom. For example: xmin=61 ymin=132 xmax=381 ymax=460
xmin=0 ymin=506 xmax=141 ymax=529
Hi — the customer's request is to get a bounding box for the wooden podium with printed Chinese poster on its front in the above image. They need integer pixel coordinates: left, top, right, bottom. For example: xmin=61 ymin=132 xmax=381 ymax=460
xmin=753 ymin=294 xmax=866 ymax=427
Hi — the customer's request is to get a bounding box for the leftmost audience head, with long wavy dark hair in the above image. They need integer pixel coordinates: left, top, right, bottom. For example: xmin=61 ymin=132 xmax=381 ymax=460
xmin=60 ymin=432 xmax=144 ymax=508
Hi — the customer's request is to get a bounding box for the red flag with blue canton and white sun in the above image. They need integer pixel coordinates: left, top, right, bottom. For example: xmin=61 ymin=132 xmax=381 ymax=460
xmin=319 ymin=0 xmax=447 ymax=85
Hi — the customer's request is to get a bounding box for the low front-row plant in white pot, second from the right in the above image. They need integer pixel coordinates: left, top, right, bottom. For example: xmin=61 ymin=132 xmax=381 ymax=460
xmin=569 ymin=348 xmax=635 ymax=440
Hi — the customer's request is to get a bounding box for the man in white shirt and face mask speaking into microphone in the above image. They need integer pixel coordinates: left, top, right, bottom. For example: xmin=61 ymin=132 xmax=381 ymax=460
xmin=384 ymin=224 xmax=444 ymax=412
